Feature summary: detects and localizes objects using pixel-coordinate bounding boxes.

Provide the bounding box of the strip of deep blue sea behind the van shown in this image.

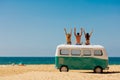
[0,57,120,65]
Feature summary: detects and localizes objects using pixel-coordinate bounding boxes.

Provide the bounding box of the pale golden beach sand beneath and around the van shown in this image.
[0,65,120,80]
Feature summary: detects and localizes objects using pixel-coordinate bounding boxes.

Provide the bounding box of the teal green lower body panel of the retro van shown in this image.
[55,56,108,70]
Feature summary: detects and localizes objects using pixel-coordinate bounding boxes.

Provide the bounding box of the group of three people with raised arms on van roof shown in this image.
[64,28,93,45]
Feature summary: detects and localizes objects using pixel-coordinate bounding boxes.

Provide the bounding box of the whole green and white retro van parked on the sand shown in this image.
[55,44,109,73]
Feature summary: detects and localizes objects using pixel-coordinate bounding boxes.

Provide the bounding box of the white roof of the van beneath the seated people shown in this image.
[57,44,104,48]
